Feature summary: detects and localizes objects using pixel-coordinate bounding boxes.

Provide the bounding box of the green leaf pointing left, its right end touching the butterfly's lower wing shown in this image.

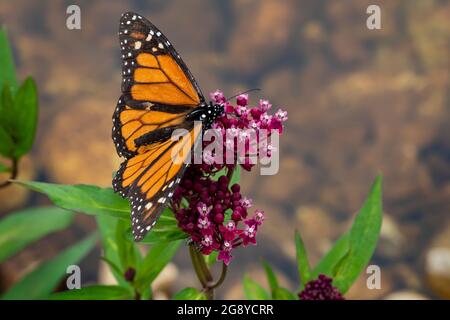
[15,181,130,220]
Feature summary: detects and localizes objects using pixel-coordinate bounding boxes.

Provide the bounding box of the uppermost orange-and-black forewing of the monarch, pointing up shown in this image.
[119,12,204,107]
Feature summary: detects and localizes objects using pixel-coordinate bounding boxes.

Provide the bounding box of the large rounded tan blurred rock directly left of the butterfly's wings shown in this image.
[39,98,120,186]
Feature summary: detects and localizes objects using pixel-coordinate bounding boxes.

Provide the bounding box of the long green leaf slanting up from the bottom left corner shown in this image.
[2,234,97,300]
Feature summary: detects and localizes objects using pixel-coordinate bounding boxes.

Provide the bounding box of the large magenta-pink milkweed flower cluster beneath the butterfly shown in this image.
[171,90,287,265]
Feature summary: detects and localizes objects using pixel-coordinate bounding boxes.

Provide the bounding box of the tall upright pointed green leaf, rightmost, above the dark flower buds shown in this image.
[333,176,383,293]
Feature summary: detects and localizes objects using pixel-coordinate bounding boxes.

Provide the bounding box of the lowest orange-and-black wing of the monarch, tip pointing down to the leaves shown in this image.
[113,124,199,241]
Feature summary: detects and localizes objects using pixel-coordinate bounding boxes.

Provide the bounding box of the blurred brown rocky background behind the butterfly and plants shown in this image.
[0,0,450,299]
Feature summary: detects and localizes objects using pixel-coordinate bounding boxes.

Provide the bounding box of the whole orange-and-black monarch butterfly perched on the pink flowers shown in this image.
[112,12,224,241]
